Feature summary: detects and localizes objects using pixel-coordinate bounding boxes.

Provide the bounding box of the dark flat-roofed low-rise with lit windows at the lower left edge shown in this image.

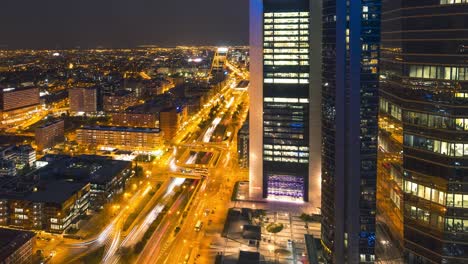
[0,177,91,233]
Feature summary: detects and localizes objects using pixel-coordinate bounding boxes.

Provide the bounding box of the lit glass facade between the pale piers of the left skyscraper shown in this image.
[263,0,310,201]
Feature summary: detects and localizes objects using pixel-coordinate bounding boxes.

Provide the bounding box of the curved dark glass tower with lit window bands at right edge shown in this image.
[379,0,468,263]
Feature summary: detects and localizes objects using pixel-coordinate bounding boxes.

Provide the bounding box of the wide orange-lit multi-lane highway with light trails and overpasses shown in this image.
[34,60,248,263]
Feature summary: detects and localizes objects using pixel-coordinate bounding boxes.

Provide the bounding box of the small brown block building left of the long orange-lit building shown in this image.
[35,119,65,151]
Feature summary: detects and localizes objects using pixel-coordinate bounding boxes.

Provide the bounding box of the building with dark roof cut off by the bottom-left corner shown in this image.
[0,228,36,264]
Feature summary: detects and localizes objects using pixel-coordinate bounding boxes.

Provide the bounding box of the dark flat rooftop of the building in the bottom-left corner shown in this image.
[0,228,36,261]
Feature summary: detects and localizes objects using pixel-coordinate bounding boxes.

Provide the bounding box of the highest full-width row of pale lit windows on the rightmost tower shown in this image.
[409,65,468,81]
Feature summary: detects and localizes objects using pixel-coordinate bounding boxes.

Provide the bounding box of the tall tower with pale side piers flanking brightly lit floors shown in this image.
[249,0,320,204]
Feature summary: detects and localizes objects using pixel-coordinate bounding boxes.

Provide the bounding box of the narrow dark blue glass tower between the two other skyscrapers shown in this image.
[321,0,380,264]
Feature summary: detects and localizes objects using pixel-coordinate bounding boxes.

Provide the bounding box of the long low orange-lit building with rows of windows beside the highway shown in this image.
[76,126,162,151]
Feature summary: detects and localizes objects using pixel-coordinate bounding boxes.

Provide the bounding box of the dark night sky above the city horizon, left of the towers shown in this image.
[0,0,248,49]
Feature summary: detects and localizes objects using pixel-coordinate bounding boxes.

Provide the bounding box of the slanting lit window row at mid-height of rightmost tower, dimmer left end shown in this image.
[404,134,468,157]
